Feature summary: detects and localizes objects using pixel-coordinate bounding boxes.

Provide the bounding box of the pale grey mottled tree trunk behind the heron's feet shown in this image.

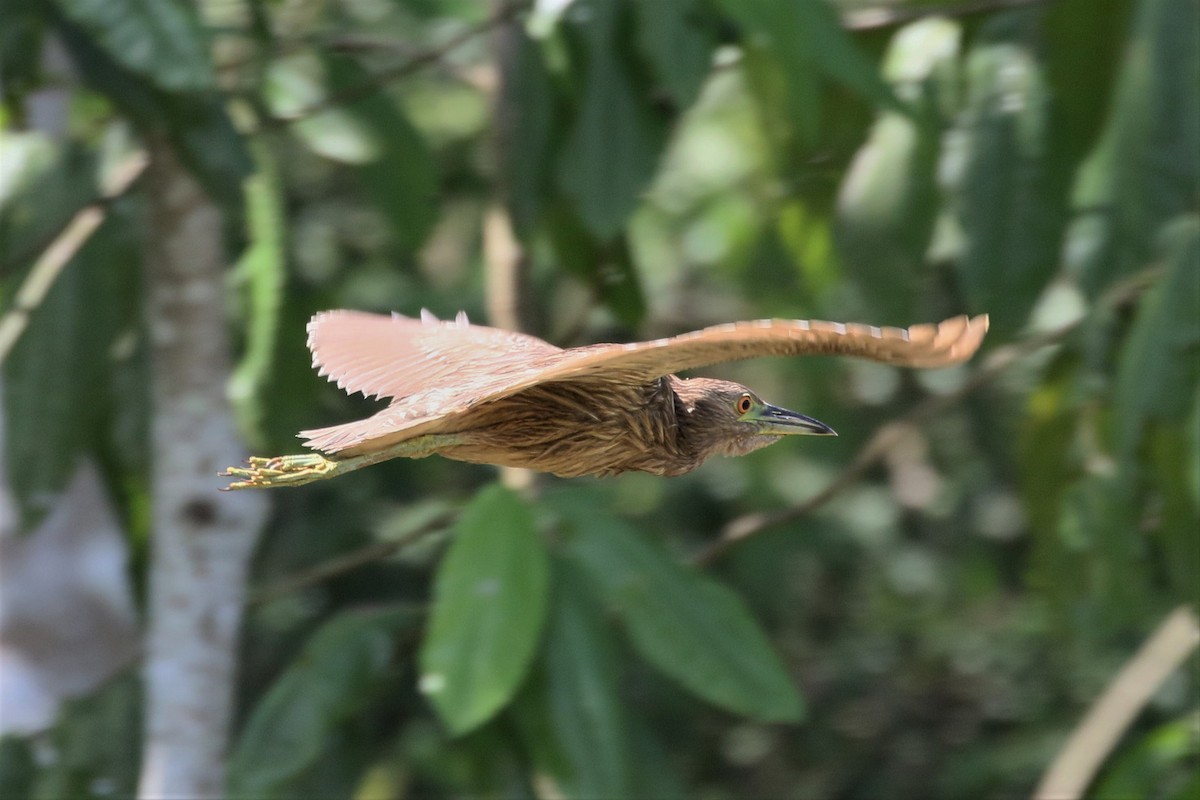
[138,142,266,799]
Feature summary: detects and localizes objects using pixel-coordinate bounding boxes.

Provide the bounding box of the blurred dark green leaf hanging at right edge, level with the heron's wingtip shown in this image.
[1112,215,1200,458]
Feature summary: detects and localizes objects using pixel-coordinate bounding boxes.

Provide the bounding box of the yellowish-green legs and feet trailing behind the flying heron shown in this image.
[217,434,460,492]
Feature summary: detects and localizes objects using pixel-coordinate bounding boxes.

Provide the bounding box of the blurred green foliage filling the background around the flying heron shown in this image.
[0,0,1200,799]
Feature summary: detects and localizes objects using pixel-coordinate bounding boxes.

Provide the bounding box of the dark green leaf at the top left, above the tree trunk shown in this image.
[58,0,216,91]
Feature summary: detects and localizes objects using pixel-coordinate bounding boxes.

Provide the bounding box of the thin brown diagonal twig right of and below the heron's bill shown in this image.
[692,267,1162,566]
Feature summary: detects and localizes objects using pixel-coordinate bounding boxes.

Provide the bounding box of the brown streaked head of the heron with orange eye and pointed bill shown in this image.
[676,378,838,457]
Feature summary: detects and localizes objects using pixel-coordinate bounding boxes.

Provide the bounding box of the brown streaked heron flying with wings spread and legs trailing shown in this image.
[221,311,988,489]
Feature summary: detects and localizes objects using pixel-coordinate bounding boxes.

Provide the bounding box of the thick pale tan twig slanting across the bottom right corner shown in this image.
[1033,606,1200,800]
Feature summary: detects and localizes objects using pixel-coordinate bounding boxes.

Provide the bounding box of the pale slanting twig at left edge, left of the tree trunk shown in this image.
[0,151,146,365]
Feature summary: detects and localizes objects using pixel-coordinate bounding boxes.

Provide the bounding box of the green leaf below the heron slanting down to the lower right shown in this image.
[558,503,804,722]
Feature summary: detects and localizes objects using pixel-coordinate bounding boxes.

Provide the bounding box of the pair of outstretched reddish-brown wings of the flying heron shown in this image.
[300,312,988,455]
